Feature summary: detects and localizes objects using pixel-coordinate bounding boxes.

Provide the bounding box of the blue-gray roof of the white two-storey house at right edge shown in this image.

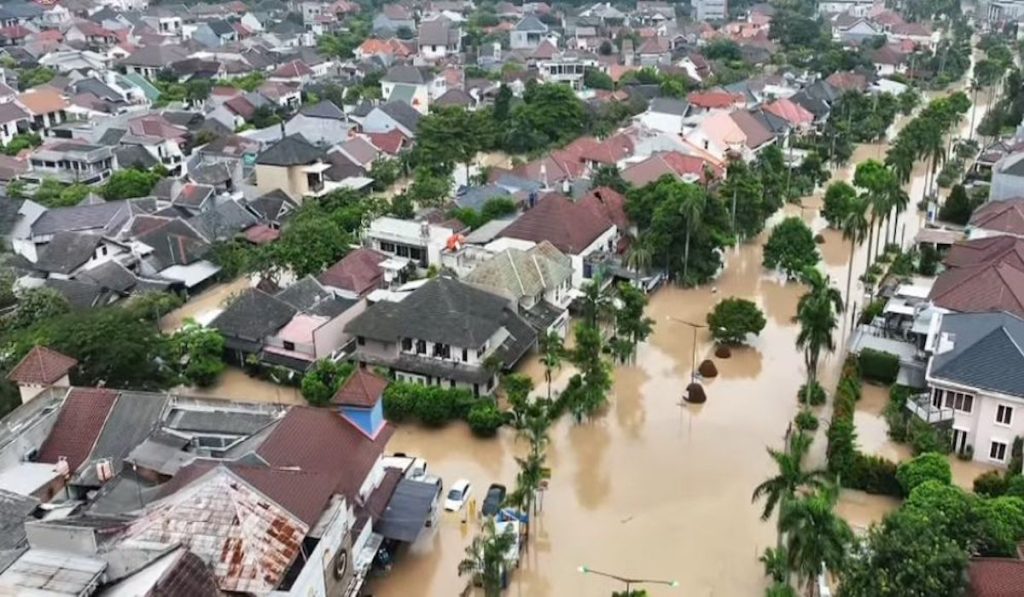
[930,312,1024,396]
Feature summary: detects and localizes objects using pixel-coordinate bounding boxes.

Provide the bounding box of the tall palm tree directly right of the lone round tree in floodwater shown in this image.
[797,267,843,392]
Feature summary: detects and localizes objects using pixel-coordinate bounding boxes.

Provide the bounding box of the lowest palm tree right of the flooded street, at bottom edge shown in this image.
[779,483,853,597]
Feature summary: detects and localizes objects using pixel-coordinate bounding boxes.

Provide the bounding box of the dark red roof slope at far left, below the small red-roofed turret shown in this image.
[39,388,118,471]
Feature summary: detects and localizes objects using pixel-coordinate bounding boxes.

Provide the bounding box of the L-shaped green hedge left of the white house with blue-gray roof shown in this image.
[825,357,902,496]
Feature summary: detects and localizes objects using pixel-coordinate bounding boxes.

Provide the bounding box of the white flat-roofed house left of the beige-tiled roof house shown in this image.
[362,216,455,270]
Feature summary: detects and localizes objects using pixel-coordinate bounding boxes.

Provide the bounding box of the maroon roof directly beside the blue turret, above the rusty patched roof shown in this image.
[257,407,394,499]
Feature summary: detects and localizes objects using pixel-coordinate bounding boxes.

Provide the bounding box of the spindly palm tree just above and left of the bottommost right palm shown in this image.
[751,432,828,565]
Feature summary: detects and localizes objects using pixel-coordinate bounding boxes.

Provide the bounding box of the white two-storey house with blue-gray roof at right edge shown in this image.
[921,311,1024,466]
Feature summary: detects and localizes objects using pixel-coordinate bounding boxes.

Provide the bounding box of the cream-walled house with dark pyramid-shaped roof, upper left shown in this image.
[255,135,331,203]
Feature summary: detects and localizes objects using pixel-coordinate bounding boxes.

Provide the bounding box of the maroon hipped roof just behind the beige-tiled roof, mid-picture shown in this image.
[501,194,614,255]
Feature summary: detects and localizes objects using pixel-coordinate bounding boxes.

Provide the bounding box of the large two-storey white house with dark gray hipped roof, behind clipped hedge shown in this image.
[346,276,537,395]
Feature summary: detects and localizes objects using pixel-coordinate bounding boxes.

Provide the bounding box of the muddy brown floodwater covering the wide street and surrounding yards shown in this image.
[368,77,995,597]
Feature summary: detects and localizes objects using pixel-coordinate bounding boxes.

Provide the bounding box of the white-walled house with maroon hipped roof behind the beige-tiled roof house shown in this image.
[500,187,629,288]
